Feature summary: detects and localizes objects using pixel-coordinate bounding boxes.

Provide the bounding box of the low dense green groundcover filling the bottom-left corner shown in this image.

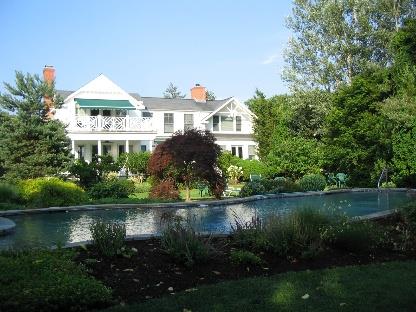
[0,250,112,312]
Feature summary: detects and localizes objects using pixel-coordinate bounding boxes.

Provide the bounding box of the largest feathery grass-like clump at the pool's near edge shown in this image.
[264,208,330,257]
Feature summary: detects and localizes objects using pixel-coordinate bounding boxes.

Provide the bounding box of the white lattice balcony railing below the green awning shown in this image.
[70,115,155,132]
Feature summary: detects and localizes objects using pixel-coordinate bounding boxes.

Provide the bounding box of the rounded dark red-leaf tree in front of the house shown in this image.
[148,129,225,201]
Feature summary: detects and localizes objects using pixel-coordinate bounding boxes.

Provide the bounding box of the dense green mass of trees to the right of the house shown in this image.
[247,5,416,187]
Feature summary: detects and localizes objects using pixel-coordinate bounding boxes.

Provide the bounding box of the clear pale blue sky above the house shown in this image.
[0,0,291,101]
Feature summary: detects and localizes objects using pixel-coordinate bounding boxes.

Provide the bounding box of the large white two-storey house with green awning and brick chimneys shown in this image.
[43,66,256,161]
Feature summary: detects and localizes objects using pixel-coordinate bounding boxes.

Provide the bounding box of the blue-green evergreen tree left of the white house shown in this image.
[0,72,71,180]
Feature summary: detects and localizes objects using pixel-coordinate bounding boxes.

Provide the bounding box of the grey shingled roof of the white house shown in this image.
[57,90,230,112]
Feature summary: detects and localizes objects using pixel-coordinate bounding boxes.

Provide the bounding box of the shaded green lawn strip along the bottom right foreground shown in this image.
[106,261,416,312]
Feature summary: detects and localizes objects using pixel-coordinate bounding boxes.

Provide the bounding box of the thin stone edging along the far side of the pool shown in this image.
[0,188,416,217]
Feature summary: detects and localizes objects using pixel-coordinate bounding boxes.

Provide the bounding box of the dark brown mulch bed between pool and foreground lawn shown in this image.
[77,214,416,303]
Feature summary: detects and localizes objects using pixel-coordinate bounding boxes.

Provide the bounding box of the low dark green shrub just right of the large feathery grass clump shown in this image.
[322,220,382,253]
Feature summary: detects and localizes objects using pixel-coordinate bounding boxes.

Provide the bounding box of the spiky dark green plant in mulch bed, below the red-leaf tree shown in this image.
[161,217,212,267]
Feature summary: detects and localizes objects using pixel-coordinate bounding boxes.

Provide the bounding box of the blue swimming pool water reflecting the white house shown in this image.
[0,191,416,249]
